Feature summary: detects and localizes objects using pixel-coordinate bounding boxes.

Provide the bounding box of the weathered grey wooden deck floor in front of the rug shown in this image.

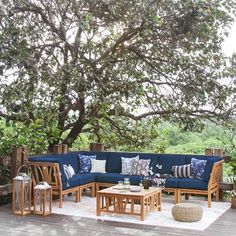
[0,206,236,236]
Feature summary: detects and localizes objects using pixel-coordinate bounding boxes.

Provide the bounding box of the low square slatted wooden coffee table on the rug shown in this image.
[97,185,161,220]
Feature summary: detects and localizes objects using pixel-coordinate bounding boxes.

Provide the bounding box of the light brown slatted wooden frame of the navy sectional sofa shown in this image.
[28,160,224,207]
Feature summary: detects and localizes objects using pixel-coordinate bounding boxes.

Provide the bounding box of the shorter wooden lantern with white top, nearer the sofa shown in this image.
[34,185,52,216]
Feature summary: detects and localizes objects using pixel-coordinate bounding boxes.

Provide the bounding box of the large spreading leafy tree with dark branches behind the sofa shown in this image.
[0,0,236,149]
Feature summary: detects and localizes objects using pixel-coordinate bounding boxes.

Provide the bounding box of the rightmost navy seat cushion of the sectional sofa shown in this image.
[178,178,208,190]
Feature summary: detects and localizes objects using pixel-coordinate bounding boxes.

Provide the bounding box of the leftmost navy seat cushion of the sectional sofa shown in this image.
[63,173,96,190]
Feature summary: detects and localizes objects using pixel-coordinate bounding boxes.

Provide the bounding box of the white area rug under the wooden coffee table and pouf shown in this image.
[52,196,230,230]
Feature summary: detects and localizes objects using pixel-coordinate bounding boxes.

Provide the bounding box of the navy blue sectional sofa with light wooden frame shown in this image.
[29,151,223,207]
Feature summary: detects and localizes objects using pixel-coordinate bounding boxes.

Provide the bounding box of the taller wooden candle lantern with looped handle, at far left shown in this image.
[12,165,32,216]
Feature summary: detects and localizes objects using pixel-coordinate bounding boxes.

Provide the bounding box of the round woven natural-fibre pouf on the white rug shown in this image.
[172,203,203,222]
